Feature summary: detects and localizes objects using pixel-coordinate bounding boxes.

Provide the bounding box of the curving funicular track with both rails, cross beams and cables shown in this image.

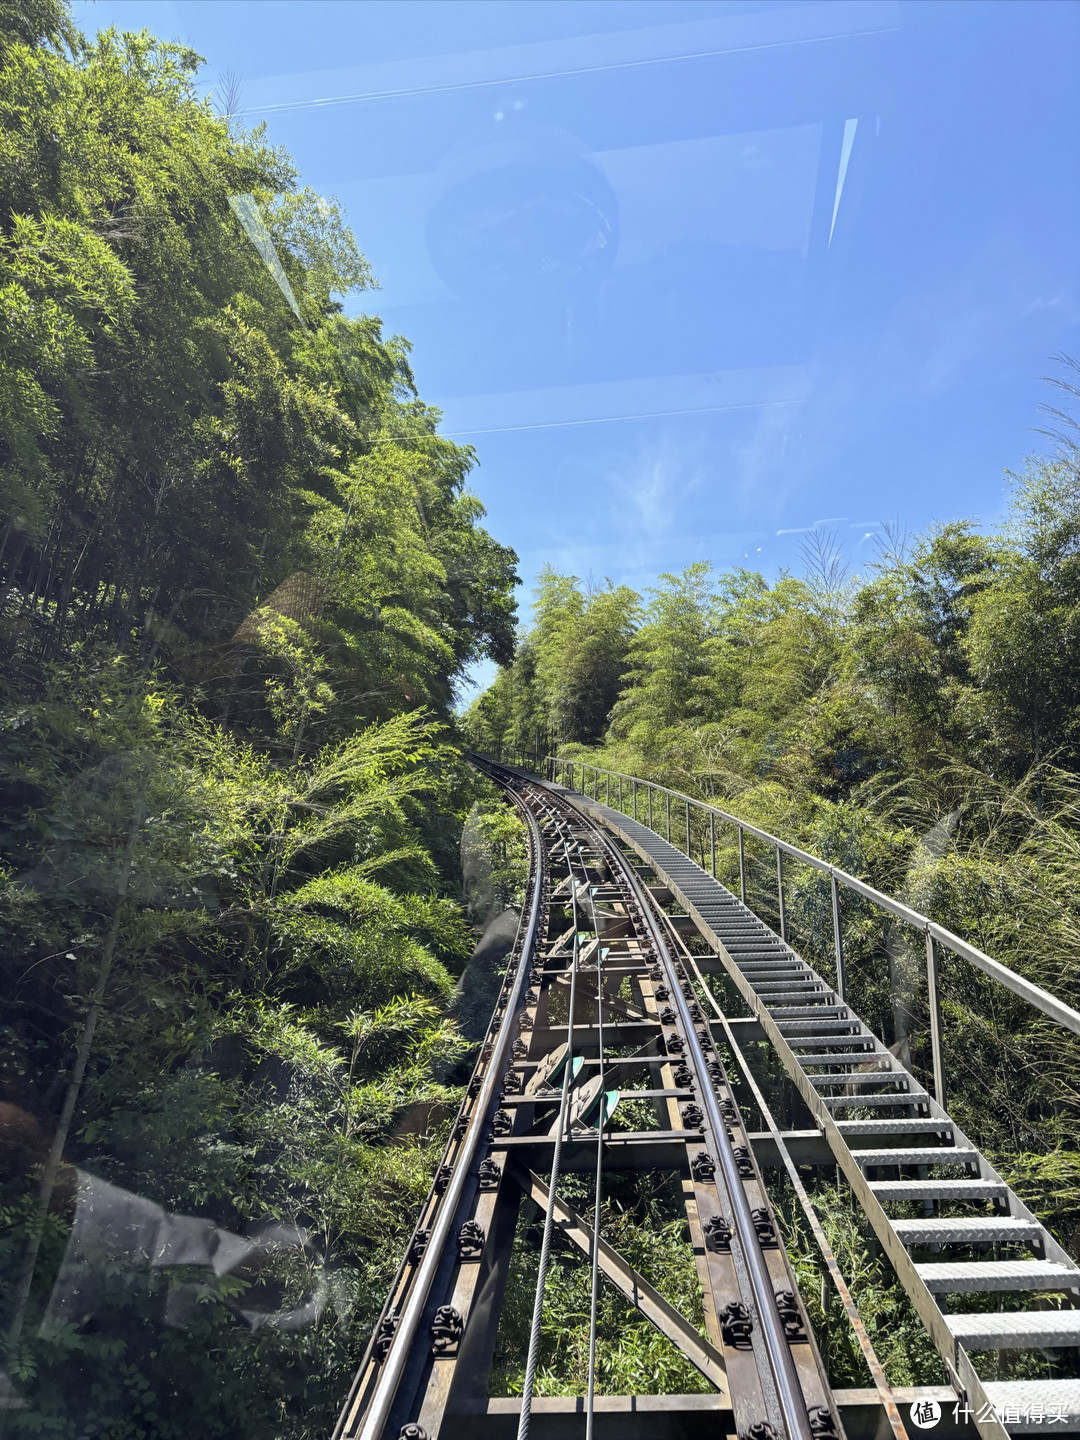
[336,762,840,1440]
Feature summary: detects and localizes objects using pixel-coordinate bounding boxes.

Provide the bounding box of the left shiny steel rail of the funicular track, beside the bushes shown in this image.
[348,789,544,1440]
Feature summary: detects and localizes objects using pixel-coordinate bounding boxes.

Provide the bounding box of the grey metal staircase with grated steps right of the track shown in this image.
[562,791,1080,1440]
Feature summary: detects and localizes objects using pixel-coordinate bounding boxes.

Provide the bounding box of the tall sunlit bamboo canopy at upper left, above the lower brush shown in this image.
[0,0,516,708]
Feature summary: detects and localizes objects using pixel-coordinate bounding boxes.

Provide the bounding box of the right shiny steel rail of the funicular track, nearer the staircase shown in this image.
[558,794,815,1440]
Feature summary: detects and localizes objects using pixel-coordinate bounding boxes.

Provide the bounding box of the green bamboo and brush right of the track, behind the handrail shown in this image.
[467,449,1080,1247]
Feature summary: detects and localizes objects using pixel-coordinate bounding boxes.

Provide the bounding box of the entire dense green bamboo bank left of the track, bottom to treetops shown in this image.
[0,0,516,1440]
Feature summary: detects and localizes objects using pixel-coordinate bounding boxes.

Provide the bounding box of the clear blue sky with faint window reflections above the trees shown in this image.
[75,0,1080,688]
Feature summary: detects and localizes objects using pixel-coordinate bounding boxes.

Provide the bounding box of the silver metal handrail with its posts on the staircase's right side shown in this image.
[500,747,1080,1104]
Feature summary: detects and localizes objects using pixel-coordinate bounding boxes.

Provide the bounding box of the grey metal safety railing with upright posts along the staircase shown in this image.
[495,747,1080,1106]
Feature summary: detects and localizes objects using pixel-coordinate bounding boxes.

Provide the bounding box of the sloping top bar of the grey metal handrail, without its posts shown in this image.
[521,756,1080,1035]
